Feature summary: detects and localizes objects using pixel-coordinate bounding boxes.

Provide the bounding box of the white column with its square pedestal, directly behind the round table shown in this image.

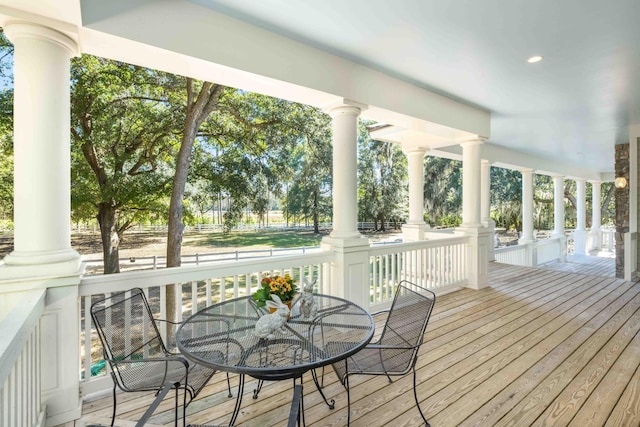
[321,100,370,307]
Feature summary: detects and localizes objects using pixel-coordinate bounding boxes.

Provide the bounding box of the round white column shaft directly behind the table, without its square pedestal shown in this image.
[329,105,361,239]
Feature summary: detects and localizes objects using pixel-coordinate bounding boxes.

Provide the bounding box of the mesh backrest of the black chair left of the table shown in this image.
[91,288,167,370]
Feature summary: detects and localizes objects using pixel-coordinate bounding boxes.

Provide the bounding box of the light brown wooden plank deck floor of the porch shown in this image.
[81,263,640,427]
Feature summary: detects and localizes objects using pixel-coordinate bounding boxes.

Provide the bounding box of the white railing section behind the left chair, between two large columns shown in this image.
[79,252,332,394]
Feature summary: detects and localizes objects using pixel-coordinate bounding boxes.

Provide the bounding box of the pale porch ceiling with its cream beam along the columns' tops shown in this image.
[0,0,640,179]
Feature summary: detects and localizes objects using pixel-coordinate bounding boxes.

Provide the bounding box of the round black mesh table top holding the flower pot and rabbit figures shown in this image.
[177,294,374,380]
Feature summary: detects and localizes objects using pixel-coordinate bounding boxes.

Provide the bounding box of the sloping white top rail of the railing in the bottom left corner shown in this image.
[0,289,47,384]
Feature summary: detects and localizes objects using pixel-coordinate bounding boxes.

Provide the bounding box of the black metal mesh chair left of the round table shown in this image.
[91,288,231,426]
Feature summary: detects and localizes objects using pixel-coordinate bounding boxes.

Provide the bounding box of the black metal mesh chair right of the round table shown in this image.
[329,280,436,427]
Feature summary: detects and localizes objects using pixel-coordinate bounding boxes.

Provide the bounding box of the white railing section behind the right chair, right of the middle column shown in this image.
[369,236,469,306]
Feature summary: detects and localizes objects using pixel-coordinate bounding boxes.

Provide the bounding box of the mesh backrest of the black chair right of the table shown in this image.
[378,280,436,370]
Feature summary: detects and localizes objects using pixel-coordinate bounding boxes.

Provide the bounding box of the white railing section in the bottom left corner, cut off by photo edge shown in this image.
[0,290,46,427]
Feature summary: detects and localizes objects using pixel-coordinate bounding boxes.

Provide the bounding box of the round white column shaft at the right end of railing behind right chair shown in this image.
[460,139,483,228]
